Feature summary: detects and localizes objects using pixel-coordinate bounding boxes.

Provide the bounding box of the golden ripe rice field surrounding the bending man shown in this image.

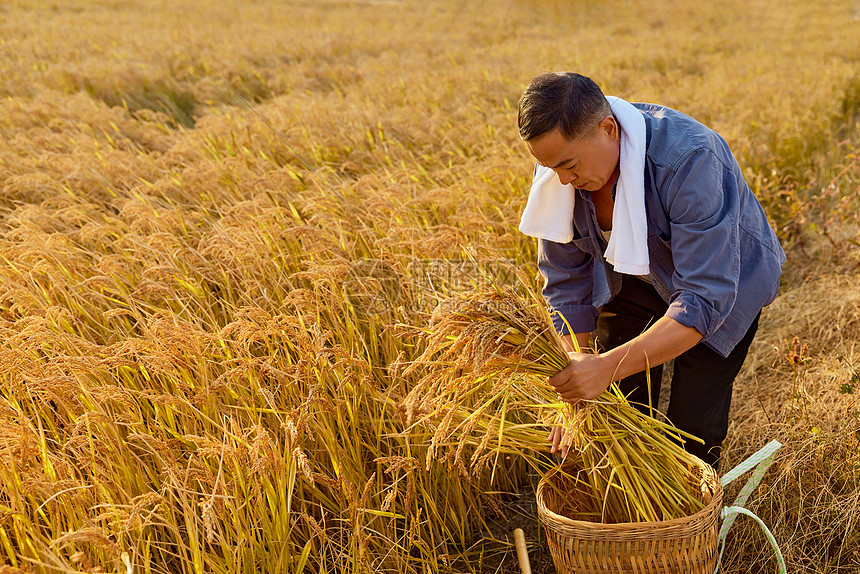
[0,0,860,574]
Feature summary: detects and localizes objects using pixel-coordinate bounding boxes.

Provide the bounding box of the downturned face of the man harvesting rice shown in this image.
[526,117,619,191]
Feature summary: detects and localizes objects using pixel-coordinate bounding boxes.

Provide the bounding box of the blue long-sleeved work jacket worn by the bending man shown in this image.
[538,104,785,357]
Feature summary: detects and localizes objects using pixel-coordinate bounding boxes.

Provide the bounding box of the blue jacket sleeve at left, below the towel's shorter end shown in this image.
[538,239,597,335]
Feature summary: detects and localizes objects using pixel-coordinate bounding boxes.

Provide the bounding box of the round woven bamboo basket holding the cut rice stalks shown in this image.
[537,462,723,574]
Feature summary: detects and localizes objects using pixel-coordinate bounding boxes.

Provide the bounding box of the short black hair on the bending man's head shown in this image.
[517,72,612,141]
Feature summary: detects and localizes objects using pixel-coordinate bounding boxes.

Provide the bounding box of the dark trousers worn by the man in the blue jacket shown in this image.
[596,275,758,468]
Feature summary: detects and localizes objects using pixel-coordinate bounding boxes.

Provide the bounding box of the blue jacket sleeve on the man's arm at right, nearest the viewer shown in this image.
[666,149,740,338]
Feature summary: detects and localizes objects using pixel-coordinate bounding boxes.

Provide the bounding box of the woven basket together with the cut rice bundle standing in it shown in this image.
[420,286,721,572]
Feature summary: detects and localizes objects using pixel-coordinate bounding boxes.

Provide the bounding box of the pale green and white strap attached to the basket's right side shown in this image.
[714,440,787,574]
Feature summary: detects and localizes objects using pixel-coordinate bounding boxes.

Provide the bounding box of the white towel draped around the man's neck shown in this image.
[519,96,649,275]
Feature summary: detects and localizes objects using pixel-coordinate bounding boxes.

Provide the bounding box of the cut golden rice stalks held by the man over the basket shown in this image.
[419,286,703,523]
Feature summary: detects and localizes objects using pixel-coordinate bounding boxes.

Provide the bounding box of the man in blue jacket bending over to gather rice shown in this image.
[519,72,785,466]
